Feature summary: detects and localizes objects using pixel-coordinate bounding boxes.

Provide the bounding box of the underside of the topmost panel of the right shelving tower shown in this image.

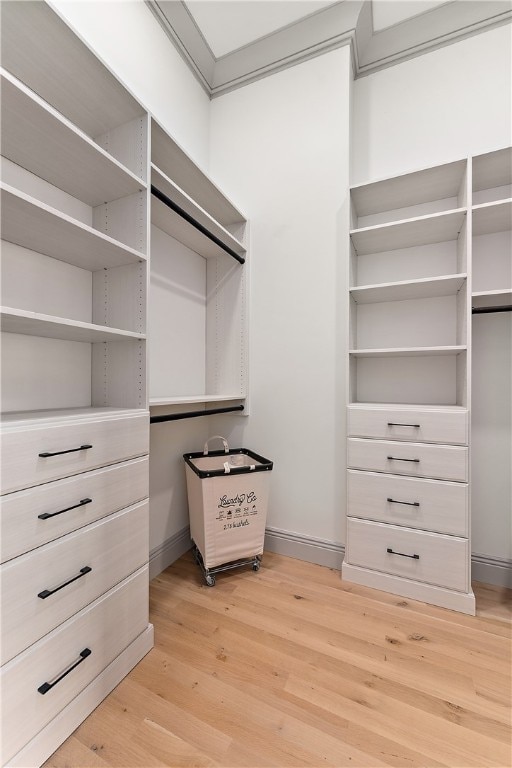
[351,160,466,216]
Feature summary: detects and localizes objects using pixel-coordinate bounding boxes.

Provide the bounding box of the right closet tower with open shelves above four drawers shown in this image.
[343,161,474,613]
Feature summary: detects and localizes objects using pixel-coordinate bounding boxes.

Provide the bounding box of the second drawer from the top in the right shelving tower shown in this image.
[348,437,468,482]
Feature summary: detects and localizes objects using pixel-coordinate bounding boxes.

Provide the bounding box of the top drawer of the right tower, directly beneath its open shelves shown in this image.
[348,407,468,445]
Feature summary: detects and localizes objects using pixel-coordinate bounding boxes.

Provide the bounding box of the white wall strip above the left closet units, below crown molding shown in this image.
[52,0,210,169]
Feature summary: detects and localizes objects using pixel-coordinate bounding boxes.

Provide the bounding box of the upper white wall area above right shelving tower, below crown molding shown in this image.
[351,25,512,184]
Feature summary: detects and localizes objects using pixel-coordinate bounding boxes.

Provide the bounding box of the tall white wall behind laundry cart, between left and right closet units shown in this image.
[210,48,350,542]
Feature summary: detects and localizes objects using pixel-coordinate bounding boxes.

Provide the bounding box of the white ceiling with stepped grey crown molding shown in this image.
[146,0,512,98]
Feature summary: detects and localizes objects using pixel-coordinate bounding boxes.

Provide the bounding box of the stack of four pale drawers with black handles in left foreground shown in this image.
[0,411,151,765]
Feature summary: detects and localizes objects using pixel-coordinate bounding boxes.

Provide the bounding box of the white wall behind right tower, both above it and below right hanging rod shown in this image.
[351,25,512,560]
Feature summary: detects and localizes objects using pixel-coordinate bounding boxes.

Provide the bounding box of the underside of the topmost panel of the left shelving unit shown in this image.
[2,2,144,138]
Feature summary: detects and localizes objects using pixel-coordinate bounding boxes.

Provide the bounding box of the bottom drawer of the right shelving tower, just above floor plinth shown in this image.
[347,519,469,592]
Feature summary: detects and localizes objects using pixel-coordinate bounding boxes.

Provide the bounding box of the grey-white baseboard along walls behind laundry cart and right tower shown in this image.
[149,527,512,589]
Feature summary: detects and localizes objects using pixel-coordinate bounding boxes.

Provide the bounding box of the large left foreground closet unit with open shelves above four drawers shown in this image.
[0,2,153,766]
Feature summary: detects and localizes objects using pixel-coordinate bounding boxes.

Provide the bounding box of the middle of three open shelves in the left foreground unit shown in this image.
[0,184,146,271]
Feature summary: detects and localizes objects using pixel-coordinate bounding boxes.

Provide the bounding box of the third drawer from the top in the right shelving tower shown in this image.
[347,470,468,536]
